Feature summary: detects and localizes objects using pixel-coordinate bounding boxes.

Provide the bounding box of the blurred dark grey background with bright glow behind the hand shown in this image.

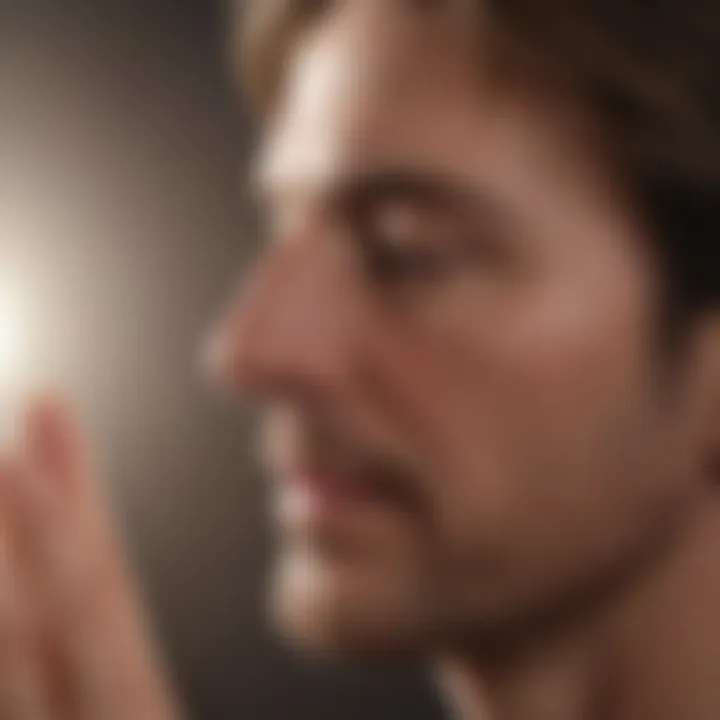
[0,0,440,720]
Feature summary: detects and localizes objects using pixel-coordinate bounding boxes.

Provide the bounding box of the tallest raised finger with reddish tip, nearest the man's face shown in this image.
[16,396,179,720]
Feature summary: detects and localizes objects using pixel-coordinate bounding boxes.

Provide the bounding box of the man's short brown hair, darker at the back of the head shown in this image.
[238,0,720,334]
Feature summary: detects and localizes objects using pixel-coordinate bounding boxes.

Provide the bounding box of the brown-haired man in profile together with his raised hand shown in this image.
[0,0,720,720]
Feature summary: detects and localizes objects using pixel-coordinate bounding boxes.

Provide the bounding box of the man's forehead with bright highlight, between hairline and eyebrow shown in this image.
[258,0,600,205]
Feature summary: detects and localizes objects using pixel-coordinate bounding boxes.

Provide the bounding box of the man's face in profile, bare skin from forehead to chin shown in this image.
[207,0,688,652]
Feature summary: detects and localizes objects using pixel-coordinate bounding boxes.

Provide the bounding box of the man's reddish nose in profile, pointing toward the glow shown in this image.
[205,236,358,400]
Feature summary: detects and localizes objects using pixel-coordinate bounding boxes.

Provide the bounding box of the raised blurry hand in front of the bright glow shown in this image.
[0,398,178,720]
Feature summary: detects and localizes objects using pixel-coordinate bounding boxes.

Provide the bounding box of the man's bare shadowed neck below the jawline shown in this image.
[439,503,720,720]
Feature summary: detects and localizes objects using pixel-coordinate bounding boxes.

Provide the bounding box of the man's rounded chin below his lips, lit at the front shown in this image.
[268,552,431,661]
